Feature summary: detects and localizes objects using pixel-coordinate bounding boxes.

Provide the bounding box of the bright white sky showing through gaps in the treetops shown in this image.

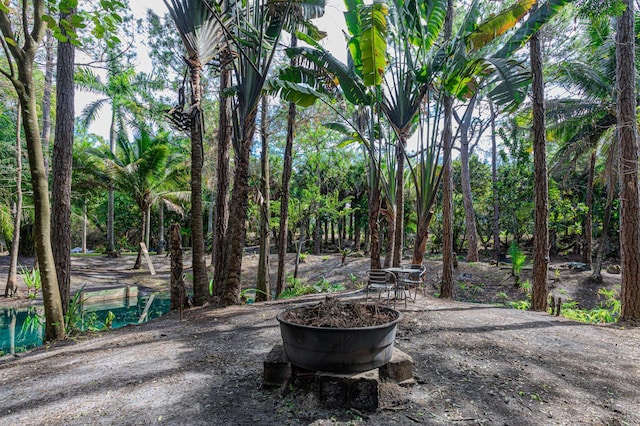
[81,0,346,139]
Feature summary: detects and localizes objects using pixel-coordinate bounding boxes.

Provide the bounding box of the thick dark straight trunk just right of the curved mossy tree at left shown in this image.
[51,10,75,312]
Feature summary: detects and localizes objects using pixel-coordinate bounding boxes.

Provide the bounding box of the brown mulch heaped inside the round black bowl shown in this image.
[281,298,399,328]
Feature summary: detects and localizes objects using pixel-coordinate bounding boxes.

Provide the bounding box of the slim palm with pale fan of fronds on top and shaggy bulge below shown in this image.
[163,0,226,305]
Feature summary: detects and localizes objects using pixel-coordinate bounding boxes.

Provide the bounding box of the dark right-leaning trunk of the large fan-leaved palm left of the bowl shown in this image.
[222,108,257,306]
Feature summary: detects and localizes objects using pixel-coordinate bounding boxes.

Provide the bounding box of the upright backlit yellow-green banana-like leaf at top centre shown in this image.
[360,3,389,86]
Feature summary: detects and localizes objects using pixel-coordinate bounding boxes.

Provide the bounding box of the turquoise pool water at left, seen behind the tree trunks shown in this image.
[0,294,171,356]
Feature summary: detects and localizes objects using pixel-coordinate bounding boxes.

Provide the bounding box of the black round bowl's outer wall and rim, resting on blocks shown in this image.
[276,307,403,374]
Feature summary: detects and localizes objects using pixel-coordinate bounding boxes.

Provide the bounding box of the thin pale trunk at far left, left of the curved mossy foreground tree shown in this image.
[4,103,22,297]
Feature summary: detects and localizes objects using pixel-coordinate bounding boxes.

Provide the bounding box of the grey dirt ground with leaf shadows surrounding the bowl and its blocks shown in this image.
[0,296,640,425]
